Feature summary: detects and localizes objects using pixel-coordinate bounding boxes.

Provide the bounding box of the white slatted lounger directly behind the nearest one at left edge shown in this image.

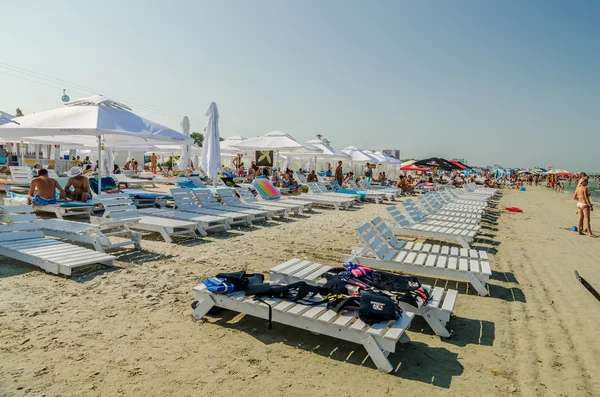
[38,219,142,252]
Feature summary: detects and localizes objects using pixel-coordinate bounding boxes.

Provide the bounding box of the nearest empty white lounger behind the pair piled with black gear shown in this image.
[342,218,492,296]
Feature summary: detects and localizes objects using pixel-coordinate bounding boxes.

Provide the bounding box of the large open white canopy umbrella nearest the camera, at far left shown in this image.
[0,95,192,147]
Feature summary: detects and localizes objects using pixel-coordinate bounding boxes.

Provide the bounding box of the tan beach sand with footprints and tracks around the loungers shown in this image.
[0,187,600,397]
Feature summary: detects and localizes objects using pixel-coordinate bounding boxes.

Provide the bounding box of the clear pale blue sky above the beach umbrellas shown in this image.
[0,0,600,171]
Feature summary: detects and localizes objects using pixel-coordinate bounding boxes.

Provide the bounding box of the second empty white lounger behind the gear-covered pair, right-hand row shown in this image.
[386,207,479,249]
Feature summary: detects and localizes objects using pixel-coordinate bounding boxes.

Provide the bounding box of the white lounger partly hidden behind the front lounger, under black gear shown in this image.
[269,258,458,338]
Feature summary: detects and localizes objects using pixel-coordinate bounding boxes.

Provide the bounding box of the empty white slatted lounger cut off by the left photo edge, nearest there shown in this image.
[0,206,115,276]
